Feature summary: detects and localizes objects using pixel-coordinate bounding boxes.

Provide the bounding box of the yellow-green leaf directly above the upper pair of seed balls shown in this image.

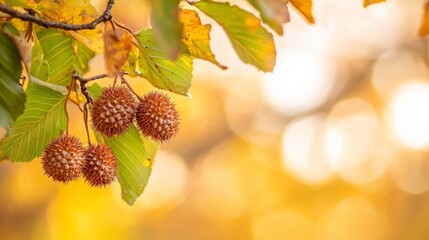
[124,29,193,95]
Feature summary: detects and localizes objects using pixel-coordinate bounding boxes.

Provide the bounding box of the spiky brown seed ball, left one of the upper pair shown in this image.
[91,87,136,137]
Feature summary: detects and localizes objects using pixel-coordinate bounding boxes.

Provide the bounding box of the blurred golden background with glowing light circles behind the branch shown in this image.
[0,0,429,240]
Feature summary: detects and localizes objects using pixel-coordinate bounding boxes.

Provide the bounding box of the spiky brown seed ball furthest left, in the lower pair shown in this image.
[42,135,85,182]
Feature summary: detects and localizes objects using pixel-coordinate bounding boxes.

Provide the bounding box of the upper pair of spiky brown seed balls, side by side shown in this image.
[92,87,179,142]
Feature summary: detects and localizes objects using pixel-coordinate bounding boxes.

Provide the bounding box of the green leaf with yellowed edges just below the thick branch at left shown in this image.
[31,29,94,86]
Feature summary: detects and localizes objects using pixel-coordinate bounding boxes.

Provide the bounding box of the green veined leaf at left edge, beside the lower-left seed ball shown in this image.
[0,83,66,162]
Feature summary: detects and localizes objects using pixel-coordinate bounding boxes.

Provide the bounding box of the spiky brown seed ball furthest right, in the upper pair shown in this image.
[136,92,179,142]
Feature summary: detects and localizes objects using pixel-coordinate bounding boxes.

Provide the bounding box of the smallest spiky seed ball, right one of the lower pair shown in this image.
[82,144,117,187]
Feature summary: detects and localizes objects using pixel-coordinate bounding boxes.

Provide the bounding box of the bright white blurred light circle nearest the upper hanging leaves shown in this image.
[263,50,335,115]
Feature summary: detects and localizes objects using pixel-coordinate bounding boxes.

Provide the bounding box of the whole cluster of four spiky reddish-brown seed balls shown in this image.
[42,86,179,187]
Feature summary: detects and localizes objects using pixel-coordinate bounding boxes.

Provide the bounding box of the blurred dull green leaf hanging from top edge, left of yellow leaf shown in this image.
[150,0,182,60]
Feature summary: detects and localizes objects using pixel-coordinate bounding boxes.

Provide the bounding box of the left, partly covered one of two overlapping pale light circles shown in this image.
[283,115,332,184]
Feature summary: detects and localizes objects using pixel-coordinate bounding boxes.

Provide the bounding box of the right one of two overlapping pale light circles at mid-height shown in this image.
[325,98,386,185]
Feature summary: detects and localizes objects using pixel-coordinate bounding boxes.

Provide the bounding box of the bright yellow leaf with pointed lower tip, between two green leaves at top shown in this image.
[179,9,227,69]
